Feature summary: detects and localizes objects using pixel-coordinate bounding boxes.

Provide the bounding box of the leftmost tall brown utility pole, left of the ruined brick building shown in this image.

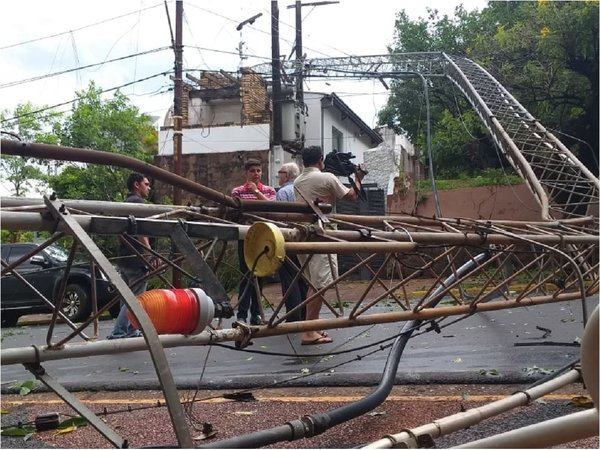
[173,0,183,205]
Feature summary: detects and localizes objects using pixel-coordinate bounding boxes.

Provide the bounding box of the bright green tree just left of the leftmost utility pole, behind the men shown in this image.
[49,82,158,201]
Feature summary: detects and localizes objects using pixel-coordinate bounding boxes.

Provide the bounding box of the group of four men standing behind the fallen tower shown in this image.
[109,146,362,345]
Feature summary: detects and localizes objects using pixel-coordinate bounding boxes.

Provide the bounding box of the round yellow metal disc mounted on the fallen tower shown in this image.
[244,222,285,277]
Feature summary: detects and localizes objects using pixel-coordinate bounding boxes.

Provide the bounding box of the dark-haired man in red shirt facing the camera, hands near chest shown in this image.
[231,159,276,325]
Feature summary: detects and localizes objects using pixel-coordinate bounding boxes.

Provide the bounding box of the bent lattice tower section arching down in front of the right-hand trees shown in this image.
[254,52,600,220]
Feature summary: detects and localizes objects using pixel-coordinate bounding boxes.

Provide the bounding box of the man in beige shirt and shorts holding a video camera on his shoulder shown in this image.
[294,146,365,345]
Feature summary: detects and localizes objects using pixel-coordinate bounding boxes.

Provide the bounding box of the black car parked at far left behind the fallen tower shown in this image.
[0,243,119,326]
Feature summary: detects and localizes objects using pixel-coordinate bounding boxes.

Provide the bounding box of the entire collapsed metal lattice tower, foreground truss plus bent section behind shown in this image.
[2,53,599,447]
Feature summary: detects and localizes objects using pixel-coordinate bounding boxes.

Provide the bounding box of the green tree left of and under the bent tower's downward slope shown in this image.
[379,6,500,177]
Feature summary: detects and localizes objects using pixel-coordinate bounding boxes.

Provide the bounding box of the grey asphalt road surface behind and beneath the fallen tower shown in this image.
[1,297,598,393]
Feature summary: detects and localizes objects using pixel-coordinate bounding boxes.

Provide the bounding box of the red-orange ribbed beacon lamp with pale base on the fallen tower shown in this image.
[127,288,215,334]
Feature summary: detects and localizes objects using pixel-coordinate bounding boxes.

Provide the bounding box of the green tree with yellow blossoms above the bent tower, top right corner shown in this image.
[473,1,600,174]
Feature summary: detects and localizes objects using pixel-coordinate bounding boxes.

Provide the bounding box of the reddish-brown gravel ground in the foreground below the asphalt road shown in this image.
[1,385,599,448]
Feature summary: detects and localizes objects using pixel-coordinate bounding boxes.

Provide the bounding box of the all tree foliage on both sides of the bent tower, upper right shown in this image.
[379,1,599,175]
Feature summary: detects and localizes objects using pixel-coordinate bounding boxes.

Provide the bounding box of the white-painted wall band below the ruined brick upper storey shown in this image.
[158,124,269,155]
